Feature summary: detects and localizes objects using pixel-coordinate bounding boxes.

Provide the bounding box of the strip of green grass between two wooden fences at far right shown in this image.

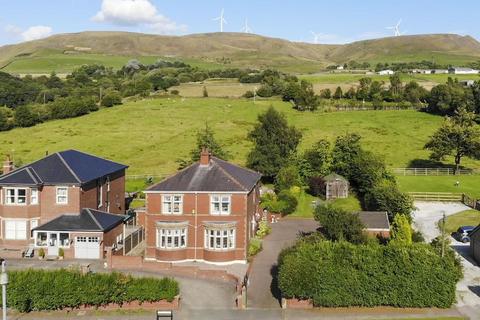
[396,175,480,199]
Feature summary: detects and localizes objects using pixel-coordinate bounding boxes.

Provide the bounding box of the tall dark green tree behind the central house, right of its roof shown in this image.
[247,107,302,180]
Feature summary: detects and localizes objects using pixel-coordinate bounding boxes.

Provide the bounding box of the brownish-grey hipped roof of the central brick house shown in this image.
[147,157,261,192]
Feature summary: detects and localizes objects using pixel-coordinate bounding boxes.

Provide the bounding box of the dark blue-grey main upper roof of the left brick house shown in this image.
[0,150,128,185]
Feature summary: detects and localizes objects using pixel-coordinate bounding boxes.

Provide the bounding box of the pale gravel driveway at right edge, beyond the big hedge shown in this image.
[414,202,480,319]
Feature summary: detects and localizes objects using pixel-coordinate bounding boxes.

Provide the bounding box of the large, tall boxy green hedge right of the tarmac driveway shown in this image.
[278,241,462,308]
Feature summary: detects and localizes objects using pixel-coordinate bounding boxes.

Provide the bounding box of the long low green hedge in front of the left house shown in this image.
[3,269,179,312]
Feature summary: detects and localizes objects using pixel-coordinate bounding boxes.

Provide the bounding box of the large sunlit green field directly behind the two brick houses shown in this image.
[0,98,480,176]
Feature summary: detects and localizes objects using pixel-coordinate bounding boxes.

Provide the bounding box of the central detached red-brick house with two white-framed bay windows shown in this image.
[138,151,261,263]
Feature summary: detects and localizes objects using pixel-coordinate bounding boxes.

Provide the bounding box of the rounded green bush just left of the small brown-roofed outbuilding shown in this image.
[314,205,366,244]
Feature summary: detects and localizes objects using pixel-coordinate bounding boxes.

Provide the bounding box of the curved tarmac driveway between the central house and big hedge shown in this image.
[247,219,318,308]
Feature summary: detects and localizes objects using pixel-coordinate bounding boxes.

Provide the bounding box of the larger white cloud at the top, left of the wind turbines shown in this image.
[92,0,187,34]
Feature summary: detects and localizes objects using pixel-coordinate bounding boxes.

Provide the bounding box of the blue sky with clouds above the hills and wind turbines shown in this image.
[0,0,480,45]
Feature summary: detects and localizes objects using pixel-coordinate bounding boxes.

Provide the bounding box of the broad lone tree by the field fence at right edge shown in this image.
[425,108,480,172]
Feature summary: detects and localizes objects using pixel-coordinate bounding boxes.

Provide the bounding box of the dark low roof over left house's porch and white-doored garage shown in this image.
[33,209,127,232]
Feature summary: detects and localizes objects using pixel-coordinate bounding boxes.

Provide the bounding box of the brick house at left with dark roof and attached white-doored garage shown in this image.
[0,150,127,258]
